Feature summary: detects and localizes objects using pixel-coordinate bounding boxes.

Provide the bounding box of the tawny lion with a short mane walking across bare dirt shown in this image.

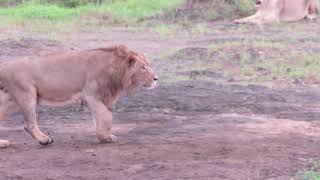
[0,46,158,148]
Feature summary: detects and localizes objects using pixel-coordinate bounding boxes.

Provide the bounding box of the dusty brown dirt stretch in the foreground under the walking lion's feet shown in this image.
[0,82,320,180]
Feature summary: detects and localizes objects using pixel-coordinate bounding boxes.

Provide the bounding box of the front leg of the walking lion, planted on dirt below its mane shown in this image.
[85,97,117,143]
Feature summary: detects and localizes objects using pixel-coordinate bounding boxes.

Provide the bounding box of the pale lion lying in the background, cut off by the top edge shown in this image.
[234,0,319,24]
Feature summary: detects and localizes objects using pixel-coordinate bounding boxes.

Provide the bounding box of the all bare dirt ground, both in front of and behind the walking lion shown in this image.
[0,22,320,180]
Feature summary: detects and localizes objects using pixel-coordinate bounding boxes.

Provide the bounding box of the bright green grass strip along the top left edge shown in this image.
[0,0,182,20]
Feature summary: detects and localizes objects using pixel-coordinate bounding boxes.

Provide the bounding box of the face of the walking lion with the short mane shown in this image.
[128,54,158,90]
